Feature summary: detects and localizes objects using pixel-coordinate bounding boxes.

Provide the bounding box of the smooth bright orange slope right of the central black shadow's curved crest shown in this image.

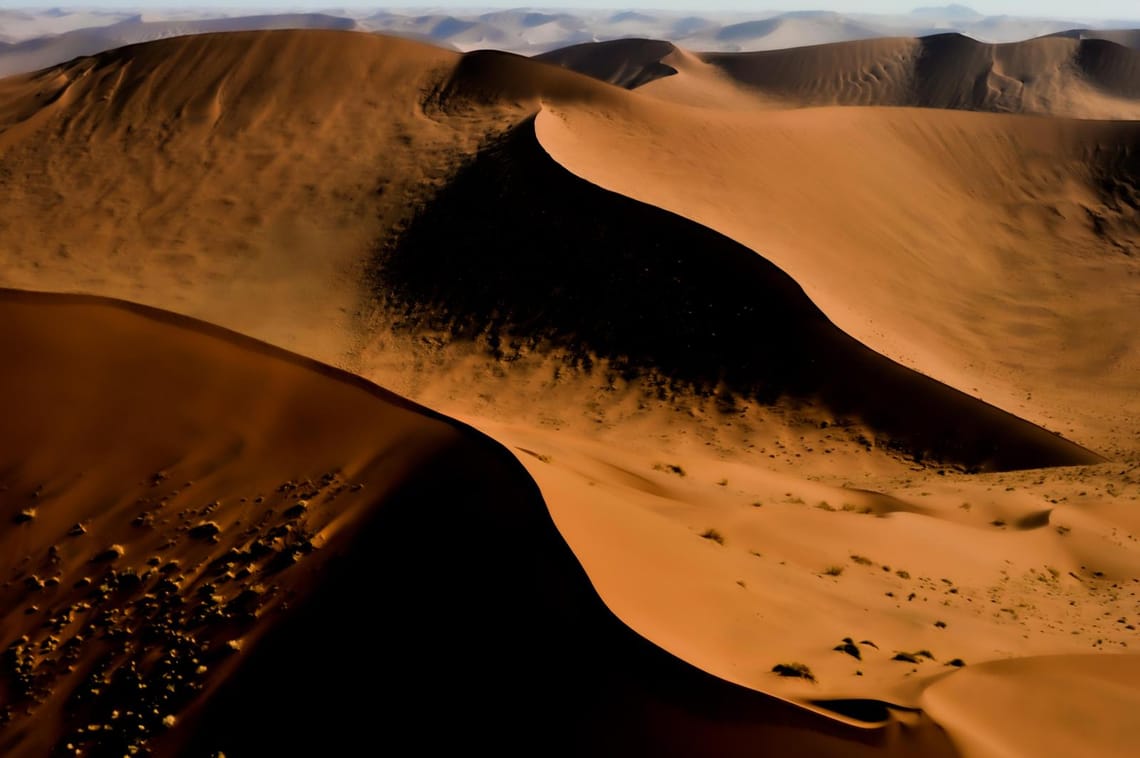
[537,98,1140,455]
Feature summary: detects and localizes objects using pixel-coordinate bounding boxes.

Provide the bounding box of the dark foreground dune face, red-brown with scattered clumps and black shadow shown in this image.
[0,291,953,756]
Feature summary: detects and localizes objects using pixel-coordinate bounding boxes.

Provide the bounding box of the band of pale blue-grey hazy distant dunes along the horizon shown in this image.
[0,6,1140,75]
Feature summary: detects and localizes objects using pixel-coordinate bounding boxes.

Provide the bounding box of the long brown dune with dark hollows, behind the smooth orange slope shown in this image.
[702,34,1140,119]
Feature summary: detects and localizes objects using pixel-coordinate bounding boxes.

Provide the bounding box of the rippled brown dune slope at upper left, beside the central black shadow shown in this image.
[0,31,495,361]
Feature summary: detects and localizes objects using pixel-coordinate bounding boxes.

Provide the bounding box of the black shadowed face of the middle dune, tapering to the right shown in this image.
[374,106,1099,468]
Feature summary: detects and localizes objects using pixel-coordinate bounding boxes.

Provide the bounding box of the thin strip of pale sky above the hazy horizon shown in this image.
[5,0,1140,19]
